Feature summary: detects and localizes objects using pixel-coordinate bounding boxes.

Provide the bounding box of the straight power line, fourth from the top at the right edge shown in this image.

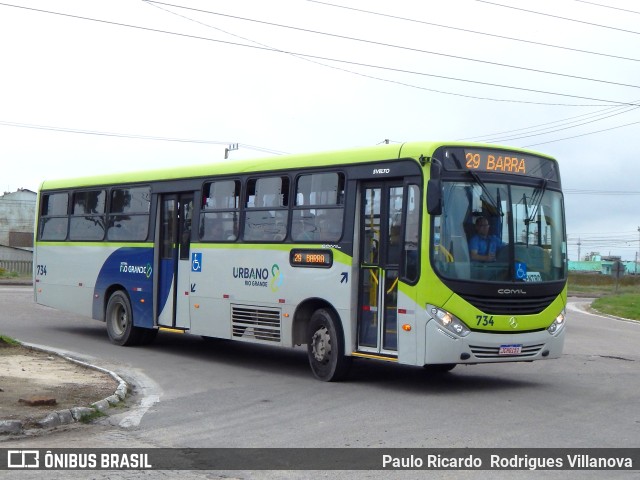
[144,0,640,88]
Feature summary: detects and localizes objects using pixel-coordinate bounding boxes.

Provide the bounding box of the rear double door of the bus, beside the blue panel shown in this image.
[154,193,193,329]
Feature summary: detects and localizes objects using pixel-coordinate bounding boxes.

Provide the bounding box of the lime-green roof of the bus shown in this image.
[40,142,551,190]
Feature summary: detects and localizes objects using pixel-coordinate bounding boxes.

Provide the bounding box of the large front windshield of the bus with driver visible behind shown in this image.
[431,181,566,283]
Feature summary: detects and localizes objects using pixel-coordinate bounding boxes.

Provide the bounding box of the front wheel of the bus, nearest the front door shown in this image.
[307,309,351,382]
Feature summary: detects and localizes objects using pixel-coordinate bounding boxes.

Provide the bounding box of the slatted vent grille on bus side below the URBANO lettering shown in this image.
[231,305,280,342]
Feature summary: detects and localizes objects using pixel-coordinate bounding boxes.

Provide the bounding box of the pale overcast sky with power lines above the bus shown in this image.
[0,0,640,260]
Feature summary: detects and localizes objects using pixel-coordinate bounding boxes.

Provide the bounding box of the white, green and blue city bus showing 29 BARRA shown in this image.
[34,142,567,381]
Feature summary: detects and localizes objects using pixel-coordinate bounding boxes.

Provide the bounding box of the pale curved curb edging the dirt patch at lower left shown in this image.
[0,343,129,435]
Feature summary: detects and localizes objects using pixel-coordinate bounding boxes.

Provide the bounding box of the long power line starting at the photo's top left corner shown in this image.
[0,3,635,106]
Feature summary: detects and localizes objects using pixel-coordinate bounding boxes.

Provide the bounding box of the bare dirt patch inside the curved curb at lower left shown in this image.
[0,339,118,427]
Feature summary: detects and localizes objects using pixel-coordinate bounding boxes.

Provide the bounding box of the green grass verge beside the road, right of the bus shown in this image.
[569,273,640,320]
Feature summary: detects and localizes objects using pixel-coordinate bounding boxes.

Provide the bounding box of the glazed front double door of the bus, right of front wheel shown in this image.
[358,181,404,356]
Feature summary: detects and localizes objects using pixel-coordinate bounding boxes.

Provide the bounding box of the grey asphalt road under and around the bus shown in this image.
[0,286,640,478]
